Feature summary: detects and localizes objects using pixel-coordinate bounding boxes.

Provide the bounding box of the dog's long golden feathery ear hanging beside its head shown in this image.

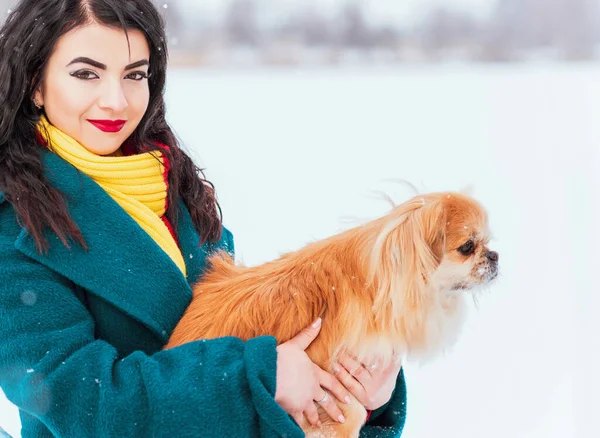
[370,195,446,325]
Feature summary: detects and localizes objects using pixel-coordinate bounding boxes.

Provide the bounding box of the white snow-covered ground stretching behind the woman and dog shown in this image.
[0,64,600,438]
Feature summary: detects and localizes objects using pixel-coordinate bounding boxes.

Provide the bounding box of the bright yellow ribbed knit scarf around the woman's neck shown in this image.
[38,116,186,276]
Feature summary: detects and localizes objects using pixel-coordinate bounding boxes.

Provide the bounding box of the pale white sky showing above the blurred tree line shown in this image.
[176,0,497,24]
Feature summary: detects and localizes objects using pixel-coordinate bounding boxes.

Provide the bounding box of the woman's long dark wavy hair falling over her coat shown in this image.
[0,0,222,252]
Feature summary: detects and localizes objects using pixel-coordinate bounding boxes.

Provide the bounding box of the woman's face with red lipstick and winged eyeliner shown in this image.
[35,24,150,155]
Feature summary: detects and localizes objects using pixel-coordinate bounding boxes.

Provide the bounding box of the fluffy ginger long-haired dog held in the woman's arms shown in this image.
[166,193,498,437]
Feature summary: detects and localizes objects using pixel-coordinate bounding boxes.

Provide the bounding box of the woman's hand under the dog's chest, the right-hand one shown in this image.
[333,352,402,411]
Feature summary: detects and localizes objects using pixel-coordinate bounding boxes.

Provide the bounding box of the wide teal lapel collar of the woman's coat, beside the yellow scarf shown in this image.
[10,151,211,343]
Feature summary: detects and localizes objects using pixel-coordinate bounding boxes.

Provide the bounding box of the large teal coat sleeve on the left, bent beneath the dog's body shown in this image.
[0,206,303,437]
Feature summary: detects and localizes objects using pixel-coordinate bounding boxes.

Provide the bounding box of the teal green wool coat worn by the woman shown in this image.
[0,152,406,438]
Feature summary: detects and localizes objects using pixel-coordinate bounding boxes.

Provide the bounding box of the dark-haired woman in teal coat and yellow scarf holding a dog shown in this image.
[0,0,405,437]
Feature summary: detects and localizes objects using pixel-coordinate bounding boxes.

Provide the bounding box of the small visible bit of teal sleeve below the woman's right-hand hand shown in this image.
[360,370,406,438]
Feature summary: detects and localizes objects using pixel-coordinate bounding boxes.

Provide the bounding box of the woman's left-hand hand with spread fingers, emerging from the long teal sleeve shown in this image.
[275,318,350,427]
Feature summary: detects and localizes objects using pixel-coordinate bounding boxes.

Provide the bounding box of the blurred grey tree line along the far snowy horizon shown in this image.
[0,0,600,62]
